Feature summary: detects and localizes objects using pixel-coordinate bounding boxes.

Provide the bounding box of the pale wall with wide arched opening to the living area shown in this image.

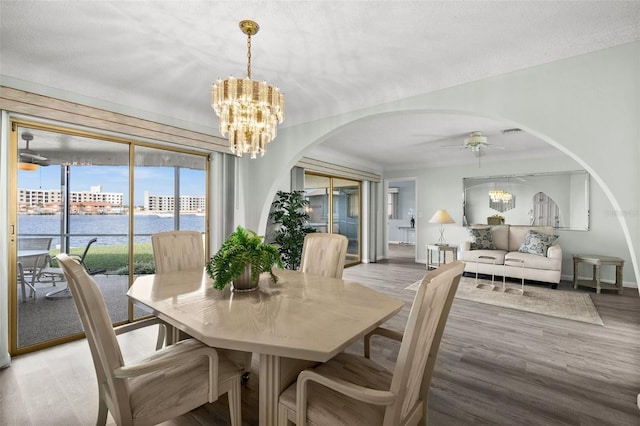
[243,42,640,288]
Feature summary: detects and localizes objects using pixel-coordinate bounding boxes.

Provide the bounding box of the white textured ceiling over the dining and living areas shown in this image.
[0,0,640,169]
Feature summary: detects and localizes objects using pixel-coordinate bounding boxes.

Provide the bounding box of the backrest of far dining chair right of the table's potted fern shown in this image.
[300,232,349,278]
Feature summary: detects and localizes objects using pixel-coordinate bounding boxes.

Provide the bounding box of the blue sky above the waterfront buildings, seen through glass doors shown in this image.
[18,165,206,206]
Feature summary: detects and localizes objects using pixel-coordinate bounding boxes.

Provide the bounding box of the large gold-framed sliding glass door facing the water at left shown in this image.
[9,120,208,355]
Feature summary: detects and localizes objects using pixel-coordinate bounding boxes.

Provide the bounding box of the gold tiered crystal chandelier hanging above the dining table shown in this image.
[211,20,284,158]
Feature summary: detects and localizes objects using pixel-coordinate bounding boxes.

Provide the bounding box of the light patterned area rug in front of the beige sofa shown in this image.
[407,277,604,325]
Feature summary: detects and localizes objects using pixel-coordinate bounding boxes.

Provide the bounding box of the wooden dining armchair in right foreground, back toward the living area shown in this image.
[278,261,464,426]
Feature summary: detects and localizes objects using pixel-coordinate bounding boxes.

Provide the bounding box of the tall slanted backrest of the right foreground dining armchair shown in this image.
[384,261,464,425]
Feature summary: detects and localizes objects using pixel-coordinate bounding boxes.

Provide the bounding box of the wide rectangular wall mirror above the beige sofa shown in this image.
[462,170,589,231]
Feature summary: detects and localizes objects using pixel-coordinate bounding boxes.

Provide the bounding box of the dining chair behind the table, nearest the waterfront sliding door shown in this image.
[151,231,252,374]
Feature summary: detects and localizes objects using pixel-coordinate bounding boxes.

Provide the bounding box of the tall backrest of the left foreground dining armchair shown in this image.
[56,253,131,424]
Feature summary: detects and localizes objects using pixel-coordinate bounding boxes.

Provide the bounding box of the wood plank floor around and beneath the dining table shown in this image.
[0,251,640,426]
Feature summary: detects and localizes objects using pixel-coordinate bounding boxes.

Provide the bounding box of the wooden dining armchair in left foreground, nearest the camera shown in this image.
[56,253,241,426]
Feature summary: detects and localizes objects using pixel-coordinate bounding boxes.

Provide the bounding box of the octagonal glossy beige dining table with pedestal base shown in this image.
[127,269,404,426]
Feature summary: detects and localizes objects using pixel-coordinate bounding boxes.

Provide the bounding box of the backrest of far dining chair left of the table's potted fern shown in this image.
[151,231,204,273]
